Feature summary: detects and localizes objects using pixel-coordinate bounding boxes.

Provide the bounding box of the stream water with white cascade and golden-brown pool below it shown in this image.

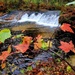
[0,11,60,37]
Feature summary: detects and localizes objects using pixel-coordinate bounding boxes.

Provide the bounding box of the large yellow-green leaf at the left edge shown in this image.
[0,29,11,43]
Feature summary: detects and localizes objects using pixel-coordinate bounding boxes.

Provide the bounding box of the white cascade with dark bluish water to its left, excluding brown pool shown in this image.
[0,11,60,27]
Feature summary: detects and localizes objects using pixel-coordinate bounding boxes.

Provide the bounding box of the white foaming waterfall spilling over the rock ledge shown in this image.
[18,11,60,27]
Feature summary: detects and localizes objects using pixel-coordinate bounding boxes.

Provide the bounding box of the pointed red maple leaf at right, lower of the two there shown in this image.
[59,41,74,53]
